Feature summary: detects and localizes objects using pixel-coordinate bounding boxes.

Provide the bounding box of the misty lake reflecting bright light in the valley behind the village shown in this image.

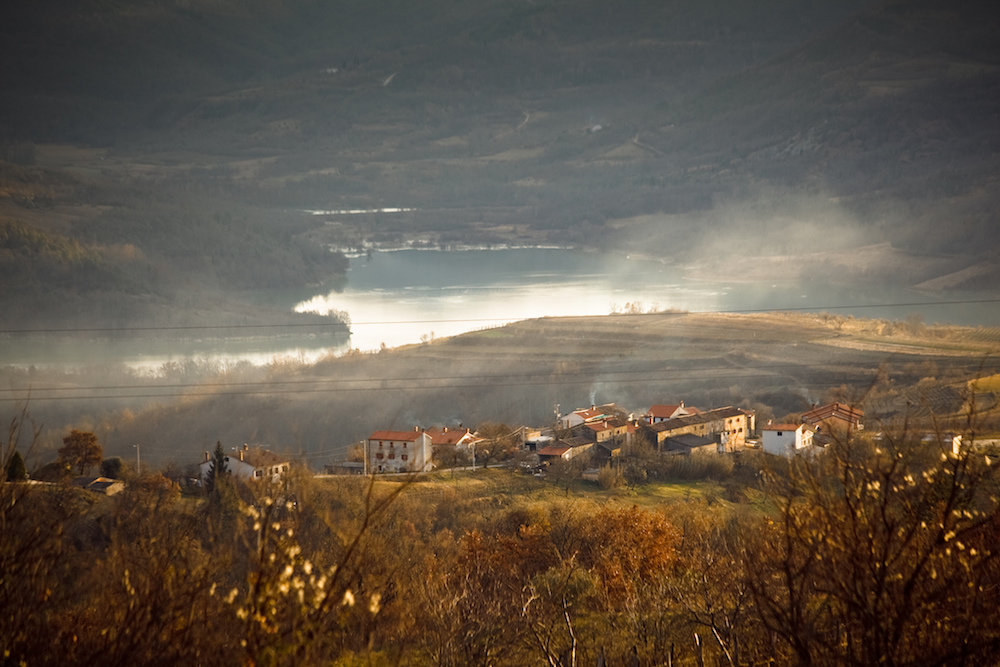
[0,248,1000,370]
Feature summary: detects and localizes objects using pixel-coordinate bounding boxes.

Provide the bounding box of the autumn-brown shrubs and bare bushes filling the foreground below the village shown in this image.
[0,414,1000,667]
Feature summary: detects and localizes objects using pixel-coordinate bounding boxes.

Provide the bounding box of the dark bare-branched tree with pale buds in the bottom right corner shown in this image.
[746,414,1000,665]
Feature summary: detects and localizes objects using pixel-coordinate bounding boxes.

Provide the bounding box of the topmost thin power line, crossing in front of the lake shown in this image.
[0,298,1000,335]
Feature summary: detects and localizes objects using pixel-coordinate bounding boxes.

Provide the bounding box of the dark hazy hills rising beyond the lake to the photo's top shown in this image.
[0,0,1000,332]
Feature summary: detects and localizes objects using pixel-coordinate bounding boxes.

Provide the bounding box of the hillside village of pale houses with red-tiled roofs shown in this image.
[191,401,864,488]
